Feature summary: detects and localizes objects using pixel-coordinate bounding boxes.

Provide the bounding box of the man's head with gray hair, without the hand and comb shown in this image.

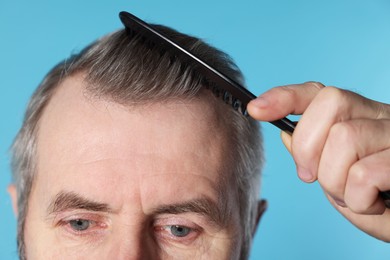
[10,23,265,259]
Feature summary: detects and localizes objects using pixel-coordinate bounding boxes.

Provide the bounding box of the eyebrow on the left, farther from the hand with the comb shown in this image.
[47,191,112,215]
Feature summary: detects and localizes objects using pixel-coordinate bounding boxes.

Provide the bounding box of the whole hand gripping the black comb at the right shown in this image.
[248,82,390,242]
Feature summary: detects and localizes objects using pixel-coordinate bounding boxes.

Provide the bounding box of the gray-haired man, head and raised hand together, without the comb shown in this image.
[9,14,390,259]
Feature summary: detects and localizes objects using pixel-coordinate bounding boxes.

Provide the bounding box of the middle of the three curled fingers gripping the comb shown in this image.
[318,119,390,205]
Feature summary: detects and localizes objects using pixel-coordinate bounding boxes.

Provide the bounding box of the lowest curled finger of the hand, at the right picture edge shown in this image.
[344,148,390,214]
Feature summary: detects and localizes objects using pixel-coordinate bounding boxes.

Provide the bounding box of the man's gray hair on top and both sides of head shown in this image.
[12,25,263,259]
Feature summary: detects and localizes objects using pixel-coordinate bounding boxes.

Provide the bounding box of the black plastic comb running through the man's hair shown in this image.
[119,12,295,133]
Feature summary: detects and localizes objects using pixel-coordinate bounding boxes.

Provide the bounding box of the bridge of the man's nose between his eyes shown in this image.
[116,221,159,260]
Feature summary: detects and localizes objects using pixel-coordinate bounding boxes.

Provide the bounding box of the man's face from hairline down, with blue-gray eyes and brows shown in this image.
[21,76,242,259]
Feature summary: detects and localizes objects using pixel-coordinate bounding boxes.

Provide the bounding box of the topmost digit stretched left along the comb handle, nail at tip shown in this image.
[247,82,324,121]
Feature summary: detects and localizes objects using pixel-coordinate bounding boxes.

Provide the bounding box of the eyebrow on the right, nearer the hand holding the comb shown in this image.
[152,198,226,227]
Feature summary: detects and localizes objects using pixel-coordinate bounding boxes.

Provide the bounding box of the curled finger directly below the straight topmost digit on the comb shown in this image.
[292,87,390,182]
